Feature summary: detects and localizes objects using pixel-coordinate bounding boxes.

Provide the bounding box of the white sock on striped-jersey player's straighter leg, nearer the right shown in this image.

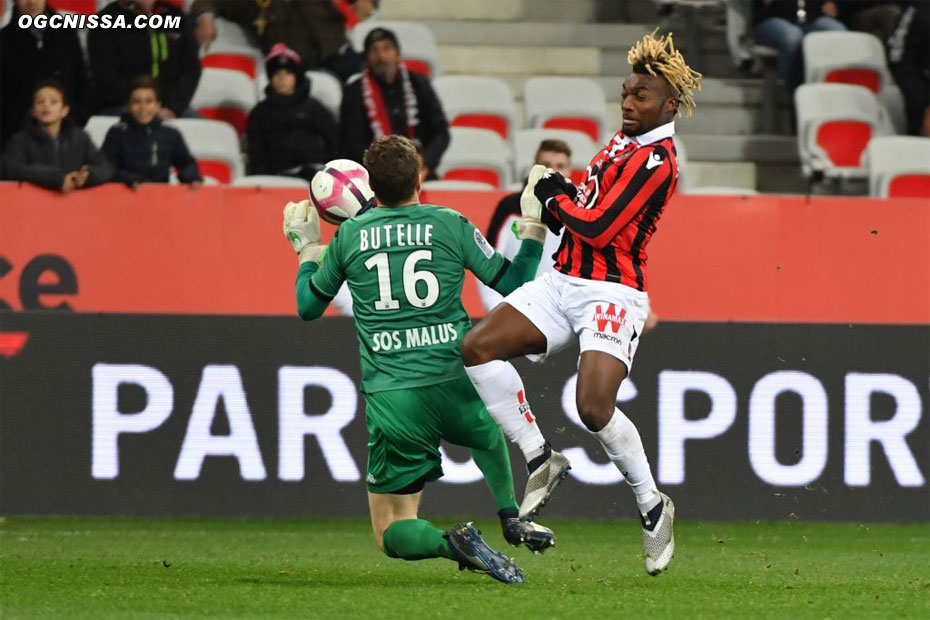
[594,408,661,514]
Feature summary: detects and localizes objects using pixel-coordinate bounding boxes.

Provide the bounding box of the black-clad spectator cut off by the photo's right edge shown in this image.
[888,0,930,137]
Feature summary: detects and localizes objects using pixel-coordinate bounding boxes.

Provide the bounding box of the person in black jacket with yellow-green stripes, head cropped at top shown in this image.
[88,0,200,120]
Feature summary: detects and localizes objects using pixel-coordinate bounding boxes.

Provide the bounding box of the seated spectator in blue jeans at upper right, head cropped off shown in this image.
[753,0,846,94]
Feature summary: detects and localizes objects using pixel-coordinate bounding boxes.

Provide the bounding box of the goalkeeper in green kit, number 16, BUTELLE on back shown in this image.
[284,135,555,583]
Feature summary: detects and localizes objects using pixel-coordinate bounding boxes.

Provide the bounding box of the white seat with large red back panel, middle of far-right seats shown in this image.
[794,84,891,178]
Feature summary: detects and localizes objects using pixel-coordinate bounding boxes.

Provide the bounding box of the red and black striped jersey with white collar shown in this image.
[546,123,678,291]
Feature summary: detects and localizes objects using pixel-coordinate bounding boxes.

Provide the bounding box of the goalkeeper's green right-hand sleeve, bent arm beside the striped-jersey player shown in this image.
[462,217,542,295]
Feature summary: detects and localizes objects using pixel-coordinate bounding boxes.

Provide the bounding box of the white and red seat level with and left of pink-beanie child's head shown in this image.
[191,69,258,136]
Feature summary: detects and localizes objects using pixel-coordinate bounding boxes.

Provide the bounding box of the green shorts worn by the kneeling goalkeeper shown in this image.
[365,377,503,493]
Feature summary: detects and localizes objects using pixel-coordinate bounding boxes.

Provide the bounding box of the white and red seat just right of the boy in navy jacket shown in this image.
[168,118,243,184]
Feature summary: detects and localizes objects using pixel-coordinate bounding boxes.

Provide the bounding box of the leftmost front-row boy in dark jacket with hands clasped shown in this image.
[3,80,113,194]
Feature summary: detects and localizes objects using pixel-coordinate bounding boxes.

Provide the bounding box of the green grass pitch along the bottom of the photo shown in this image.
[0,517,930,620]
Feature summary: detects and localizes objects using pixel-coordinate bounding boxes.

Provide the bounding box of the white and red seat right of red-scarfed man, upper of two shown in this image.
[433,75,515,140]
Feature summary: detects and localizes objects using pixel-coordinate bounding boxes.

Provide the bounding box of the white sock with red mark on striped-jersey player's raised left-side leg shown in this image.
[465,360,546,463]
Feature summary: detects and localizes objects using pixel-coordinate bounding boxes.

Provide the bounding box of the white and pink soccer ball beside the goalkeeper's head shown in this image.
[310,159,375,226]
